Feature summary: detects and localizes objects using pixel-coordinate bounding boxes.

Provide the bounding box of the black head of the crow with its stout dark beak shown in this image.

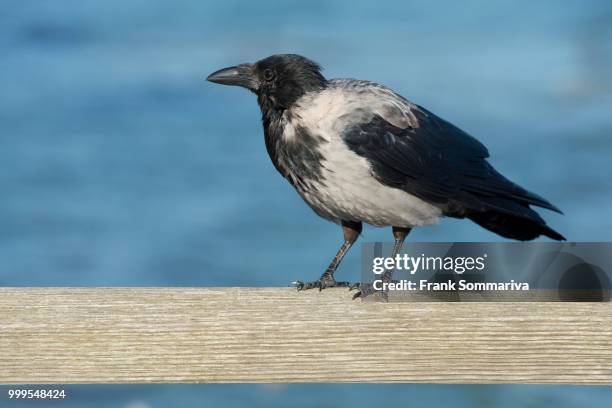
[206,54,327,110]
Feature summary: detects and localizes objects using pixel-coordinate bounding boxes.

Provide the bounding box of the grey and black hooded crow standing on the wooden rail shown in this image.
[207,54,565,290]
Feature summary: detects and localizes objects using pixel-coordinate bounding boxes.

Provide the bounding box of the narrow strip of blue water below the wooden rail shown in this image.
[0,384,610,408]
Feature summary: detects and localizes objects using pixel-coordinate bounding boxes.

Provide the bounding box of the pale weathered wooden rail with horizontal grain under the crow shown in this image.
[0,288,612,384]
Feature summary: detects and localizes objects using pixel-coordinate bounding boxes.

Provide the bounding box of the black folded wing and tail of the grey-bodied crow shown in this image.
[343,105,563,240]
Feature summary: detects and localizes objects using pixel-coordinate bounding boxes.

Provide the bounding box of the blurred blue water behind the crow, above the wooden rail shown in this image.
[0,0,612,406]
